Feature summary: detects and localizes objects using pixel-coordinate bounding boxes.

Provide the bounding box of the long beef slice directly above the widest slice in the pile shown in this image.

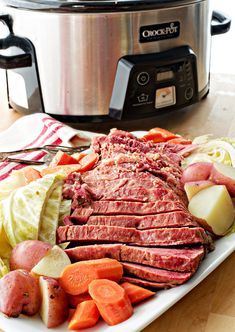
[71,211,198,230]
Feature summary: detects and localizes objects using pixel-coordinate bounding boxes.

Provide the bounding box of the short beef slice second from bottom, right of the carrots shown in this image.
[122,263,193,285]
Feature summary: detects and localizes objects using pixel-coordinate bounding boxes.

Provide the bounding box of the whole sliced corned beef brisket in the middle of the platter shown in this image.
[57,129,213,288]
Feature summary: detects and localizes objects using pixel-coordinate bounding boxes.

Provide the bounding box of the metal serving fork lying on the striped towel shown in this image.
[0,144,89,165]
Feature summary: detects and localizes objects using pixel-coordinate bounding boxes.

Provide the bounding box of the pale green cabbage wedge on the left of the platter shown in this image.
[1,174,62,247]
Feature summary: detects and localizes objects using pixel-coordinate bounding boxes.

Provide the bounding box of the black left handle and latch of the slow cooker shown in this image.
[0,15,32,69]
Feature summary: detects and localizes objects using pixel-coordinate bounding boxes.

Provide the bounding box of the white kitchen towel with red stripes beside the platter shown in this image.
[0,113,94,181]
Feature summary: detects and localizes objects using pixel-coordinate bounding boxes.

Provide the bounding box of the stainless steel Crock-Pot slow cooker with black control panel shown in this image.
[0,0,231,121]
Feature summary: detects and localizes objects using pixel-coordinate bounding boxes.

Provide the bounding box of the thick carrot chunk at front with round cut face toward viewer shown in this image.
[89,279,133,325]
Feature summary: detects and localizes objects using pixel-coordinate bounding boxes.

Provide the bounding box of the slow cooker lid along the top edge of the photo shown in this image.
[0,0,205,12]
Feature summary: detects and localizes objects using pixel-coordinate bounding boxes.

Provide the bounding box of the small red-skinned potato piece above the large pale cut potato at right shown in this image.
[181,162,213,184]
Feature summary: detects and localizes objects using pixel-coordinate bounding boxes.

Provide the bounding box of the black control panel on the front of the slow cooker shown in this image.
[109,46,198,120]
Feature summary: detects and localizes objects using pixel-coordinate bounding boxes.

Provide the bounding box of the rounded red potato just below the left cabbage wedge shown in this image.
[10,240,52,271]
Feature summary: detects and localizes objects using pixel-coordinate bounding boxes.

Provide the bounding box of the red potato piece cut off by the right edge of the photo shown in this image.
[210,163,235,197]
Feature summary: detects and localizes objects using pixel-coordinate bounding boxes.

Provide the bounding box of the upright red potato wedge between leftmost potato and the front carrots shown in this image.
[39,277,69,328]
